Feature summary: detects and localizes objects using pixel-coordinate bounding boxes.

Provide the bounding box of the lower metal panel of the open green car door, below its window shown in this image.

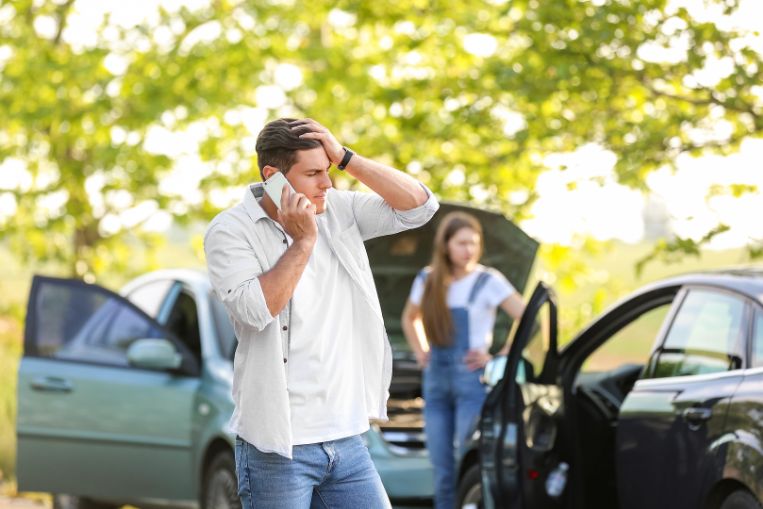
[17,358,199,500]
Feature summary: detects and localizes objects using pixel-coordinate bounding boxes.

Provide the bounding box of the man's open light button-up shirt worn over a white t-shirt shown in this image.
[204,183,439,458]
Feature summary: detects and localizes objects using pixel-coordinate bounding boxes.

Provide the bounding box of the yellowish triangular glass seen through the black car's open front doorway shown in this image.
[580,303,670,373]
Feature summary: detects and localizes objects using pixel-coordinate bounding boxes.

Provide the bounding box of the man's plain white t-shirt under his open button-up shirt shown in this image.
[286,216,369,445]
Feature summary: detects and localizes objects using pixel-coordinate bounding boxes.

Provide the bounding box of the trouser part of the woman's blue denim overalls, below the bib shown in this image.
[423,358,487,509]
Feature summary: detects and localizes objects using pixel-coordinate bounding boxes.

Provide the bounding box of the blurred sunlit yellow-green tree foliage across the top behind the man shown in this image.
[0,0,763,277]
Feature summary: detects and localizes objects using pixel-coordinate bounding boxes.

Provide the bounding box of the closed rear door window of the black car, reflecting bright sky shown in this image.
[652,290,745,378]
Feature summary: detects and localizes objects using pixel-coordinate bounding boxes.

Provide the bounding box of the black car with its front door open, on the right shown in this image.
[459,269,763,509]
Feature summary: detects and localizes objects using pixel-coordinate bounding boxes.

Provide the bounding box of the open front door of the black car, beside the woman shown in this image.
[480,283,569,509]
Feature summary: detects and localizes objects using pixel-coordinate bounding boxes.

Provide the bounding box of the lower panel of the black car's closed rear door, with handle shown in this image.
[616,372,742,509]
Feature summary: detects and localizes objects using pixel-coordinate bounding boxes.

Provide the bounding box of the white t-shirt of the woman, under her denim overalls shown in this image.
[408,265,516,351]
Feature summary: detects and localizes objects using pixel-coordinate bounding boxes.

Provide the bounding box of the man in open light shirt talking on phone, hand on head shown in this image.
[204,118,439,509]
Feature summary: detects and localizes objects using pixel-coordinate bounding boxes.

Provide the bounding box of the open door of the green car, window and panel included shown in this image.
[17,276,200,500]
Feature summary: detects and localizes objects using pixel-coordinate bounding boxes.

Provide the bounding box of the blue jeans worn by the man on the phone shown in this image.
[236,435,391,509]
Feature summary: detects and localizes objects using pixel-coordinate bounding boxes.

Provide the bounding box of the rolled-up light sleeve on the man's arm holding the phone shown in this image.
[204,223,273,331]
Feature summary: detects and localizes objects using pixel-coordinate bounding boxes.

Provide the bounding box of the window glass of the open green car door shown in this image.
[30,283,164,366]
